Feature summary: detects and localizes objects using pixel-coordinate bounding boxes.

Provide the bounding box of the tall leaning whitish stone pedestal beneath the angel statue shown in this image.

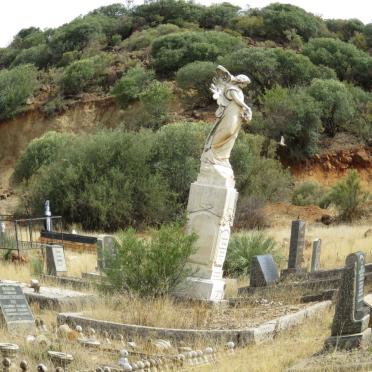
[177,163,238,301]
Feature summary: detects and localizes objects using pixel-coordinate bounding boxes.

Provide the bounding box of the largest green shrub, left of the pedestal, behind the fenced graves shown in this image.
[25,130,177,231]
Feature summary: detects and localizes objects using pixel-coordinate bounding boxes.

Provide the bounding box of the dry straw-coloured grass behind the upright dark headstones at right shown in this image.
[266,225,372,269]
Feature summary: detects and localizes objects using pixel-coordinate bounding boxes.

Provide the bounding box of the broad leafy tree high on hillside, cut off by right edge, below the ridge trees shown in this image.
[304,38,372,89]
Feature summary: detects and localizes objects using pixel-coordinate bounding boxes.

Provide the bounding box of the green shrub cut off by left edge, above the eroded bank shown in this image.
[0,65,38,120]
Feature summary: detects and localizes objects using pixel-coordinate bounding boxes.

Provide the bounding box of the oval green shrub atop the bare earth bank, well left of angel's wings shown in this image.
[112,65,155,107]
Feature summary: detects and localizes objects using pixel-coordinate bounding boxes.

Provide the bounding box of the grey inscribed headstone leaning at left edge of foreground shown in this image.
[0,284,35,330]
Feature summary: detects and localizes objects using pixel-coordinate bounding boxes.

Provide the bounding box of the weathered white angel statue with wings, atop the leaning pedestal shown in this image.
[201,66,252,168]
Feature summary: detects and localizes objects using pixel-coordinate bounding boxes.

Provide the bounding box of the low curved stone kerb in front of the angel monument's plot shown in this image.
[57,301,332,346]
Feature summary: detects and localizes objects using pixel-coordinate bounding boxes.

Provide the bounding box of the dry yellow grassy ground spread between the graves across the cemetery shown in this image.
[0,224,372,371]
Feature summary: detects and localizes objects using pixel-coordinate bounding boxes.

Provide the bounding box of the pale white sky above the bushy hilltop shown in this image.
[0,0,372,47]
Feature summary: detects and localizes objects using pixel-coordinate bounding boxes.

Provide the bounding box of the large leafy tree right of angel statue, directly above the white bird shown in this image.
[261,86,322,160]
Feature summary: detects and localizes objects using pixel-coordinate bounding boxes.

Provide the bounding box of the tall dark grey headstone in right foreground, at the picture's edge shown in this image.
[325,252,371,349]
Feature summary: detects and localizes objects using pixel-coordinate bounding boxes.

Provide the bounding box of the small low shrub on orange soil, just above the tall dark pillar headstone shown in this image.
[292,181,326,207]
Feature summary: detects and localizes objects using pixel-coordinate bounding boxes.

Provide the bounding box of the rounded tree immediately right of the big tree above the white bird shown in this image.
[308,79,355,136]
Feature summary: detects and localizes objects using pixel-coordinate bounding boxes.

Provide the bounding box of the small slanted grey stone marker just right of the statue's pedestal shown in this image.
[250,254,279,287]
